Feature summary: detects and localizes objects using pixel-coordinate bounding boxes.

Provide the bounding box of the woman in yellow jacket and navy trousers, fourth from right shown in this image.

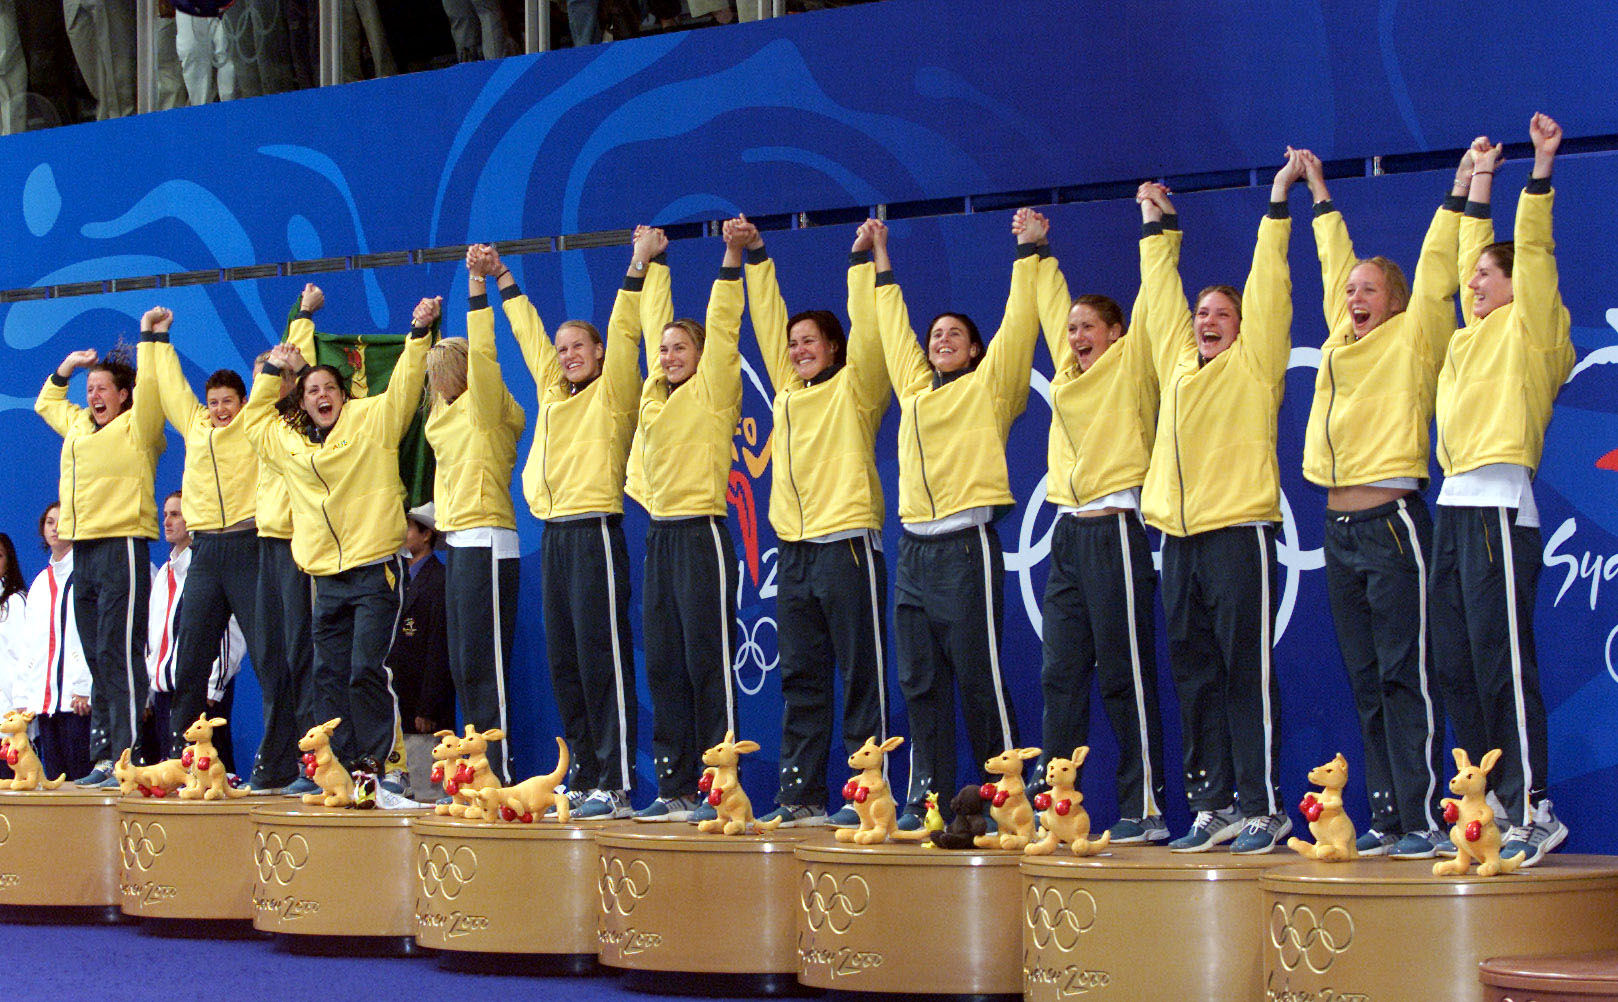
[1024,212,1180,845]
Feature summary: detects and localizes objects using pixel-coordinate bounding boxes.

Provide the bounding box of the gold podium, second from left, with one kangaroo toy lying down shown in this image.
[116,796,275,931]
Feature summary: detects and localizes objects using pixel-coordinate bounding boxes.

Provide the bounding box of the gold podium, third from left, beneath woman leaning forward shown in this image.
[251,801,427,955]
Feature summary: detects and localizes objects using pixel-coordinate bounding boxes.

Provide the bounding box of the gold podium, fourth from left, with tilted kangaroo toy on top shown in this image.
[411,814,621,974]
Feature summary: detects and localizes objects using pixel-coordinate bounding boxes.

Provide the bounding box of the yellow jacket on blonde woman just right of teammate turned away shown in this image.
[500,264,653,518]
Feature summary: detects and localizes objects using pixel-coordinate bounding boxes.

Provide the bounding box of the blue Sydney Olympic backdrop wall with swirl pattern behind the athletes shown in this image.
[0,0,1618,851]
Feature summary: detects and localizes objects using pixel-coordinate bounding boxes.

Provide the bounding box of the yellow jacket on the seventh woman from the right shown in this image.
[626,264,743,518]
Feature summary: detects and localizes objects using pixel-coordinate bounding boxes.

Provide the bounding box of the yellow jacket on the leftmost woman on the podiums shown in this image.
[34,340,168,541]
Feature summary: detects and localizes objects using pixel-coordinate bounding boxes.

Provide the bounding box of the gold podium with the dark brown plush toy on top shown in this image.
[793,843,1023,996]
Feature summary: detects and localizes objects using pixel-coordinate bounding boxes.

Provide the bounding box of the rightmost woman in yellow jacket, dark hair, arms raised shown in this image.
[1432,115,1574,866]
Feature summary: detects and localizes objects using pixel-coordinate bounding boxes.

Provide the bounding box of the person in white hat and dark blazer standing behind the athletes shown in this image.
[388,502,455,800]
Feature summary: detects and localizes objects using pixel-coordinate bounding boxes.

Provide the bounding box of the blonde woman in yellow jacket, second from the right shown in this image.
[1304,151,1472,860]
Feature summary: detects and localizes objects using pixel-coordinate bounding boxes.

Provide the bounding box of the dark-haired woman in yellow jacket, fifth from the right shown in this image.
[870,213,1039,830]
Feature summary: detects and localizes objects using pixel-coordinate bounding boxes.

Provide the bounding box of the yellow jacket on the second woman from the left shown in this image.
[152,333,259,533]
